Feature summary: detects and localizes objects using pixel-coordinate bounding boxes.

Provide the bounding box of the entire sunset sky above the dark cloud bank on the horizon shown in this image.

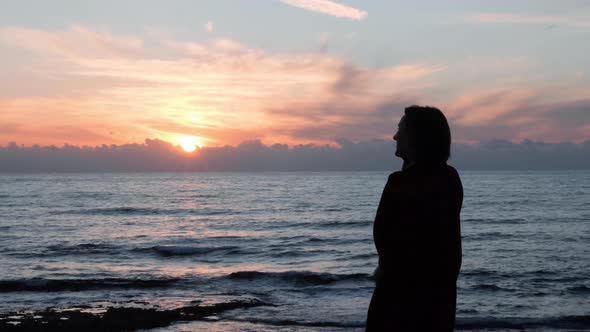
[0,0,590,147]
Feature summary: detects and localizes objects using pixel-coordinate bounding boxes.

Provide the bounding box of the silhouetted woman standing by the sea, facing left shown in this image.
[366,106,463,332]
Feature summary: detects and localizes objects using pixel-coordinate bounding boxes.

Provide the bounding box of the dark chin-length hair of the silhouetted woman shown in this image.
[405,105,451,163]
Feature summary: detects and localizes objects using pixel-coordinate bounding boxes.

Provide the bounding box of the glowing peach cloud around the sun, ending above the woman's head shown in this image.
[0,26,443,145]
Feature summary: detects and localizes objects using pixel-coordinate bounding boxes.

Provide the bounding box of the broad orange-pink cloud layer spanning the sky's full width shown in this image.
[0,26,590,146]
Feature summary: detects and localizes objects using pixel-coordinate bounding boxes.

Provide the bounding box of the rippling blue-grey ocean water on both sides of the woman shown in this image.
[0,171,590,331]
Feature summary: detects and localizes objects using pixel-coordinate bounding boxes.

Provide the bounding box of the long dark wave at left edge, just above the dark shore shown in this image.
[0,278,179,293]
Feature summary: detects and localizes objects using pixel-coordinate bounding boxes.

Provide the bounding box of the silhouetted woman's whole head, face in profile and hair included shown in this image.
[393,106,451,163]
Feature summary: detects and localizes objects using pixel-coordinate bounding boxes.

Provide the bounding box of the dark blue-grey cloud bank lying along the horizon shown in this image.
[0,139,590,172]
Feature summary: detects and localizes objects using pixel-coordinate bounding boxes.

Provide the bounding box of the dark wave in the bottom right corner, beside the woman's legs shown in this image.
[455,315,590,330]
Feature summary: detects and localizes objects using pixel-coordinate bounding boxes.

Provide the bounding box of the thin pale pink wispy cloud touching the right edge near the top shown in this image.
[466,13,590,28]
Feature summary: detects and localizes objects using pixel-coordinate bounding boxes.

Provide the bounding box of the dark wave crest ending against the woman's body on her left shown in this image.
[228,271,372,285]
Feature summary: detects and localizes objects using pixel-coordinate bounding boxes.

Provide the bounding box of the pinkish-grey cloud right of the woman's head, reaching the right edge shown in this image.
[443,88,590,142]
